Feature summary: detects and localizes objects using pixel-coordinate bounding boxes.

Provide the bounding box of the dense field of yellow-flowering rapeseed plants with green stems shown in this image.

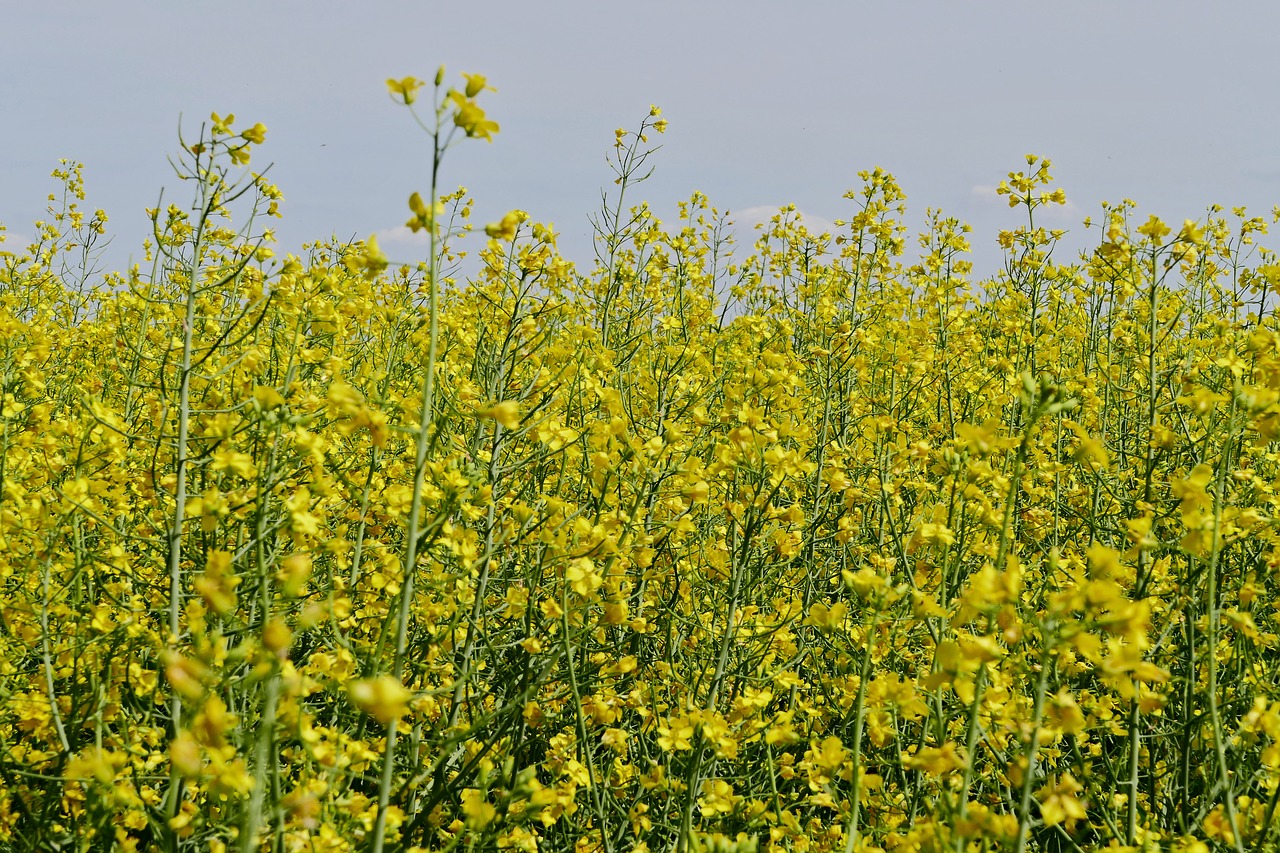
[0,69,1280,853]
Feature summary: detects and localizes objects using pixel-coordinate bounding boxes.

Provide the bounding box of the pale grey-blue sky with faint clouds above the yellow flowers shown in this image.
[0,0,1280,278]
